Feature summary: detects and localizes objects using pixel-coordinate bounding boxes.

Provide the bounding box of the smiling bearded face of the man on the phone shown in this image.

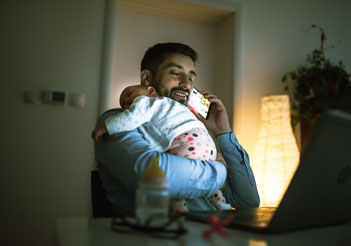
[151,55,196,105]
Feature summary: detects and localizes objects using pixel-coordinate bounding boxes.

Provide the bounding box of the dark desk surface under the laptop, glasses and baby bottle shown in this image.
[56,218,351,246]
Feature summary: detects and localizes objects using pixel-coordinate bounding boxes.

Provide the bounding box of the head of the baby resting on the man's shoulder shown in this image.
[119,85,159,109]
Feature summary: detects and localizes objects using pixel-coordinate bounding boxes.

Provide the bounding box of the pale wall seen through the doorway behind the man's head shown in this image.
[111,9,215,107]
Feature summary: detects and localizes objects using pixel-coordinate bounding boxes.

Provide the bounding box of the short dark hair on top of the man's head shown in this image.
[141,43,198,74]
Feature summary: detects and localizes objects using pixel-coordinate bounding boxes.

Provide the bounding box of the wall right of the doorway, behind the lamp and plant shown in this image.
[235,0,351,157]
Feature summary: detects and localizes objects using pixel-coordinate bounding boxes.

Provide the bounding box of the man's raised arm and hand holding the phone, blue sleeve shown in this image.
[194,92,260,208]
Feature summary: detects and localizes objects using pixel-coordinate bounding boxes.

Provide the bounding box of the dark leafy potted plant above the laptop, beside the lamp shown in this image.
[282,25,351,151]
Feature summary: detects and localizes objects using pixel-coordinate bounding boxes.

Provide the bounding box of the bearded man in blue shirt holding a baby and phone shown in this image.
[95,43,259,214]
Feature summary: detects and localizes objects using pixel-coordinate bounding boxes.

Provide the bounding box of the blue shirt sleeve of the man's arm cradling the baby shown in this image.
[95,111,227,199]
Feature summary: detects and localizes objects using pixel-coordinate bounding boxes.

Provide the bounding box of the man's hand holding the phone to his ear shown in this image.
[191,91,232,136]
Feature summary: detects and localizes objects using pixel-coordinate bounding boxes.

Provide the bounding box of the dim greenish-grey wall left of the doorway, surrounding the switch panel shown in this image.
[0,0,104,245]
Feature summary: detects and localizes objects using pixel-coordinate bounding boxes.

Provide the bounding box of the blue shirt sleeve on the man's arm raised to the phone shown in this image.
[217,132,260,208]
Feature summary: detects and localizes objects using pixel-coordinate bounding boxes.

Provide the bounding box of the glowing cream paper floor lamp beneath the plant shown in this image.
[252,95,299,207]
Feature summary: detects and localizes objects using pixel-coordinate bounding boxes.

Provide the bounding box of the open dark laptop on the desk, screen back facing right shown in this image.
[185,110,351,233]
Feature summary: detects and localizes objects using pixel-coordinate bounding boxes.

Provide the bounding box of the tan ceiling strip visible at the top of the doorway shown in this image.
[117,0,232,24]
